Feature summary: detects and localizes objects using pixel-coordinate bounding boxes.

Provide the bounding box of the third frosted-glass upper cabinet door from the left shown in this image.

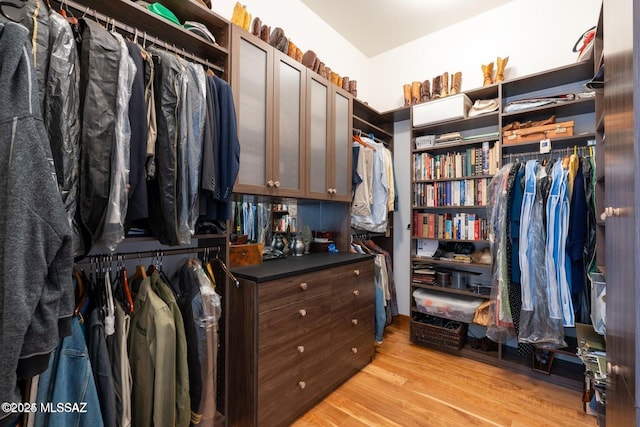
[307,73,331,199]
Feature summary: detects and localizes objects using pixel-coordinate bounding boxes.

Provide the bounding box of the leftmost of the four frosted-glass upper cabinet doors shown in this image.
[231,26,273,194]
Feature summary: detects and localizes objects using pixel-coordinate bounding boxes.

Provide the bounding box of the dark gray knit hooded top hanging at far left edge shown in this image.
[0,22,74,424]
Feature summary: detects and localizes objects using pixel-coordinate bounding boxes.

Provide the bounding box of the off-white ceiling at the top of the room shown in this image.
[301,0,512,58]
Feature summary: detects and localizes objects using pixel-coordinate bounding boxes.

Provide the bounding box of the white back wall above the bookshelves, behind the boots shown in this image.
[368,0,602,111]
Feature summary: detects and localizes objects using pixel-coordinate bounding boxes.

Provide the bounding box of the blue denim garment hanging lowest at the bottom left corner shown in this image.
[34,317,103,427]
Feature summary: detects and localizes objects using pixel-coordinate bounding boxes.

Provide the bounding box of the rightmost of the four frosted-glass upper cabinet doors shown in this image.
[330,86,353,202]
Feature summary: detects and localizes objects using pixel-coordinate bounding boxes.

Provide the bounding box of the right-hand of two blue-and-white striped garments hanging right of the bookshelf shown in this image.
[545,160,575,326]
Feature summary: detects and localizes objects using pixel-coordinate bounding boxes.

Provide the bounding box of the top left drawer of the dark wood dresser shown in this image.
[258,270,332,312]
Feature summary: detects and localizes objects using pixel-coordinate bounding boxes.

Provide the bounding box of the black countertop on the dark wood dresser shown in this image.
[231,252,373,282]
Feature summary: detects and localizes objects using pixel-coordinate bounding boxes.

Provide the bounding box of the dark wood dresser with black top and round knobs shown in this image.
[227,253,375,427]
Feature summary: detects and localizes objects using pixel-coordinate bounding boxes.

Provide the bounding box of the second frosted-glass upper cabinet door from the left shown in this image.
[270,52,306,197]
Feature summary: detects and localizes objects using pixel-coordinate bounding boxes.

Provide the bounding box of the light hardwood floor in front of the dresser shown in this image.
[293,317,597,427]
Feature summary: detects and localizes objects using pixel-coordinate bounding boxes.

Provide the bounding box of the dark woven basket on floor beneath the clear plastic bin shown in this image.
[409,313,468,350]
